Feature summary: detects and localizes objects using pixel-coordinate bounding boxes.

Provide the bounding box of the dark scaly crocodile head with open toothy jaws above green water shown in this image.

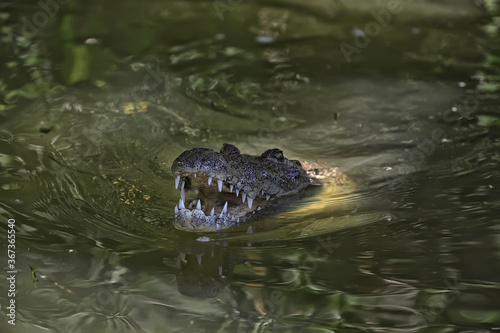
[172,144,312,231]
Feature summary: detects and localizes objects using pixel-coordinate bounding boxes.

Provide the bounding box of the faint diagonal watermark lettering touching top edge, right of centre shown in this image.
[339,0,403,64]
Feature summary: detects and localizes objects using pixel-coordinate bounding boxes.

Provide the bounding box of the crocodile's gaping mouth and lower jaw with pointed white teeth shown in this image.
[174,171,276,232]
